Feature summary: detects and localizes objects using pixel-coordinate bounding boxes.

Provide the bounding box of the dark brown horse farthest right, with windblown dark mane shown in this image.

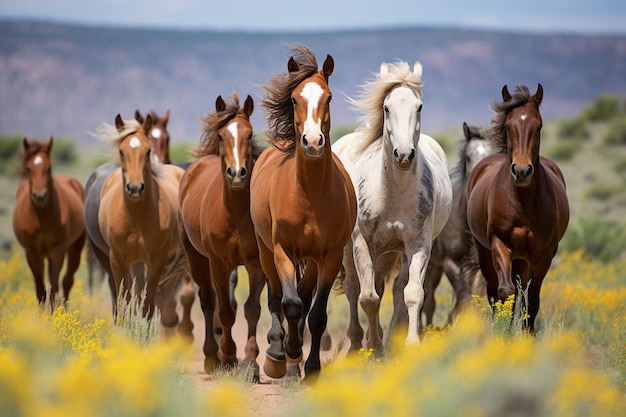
[467,84,569,333]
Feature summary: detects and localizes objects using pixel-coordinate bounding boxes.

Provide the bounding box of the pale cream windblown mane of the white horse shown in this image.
[348,61,423,155]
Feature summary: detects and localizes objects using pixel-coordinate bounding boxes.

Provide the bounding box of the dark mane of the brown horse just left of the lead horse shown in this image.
[191,92,263,160]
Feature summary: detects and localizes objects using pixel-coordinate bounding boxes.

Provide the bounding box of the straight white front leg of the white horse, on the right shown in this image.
[404,241,431,344]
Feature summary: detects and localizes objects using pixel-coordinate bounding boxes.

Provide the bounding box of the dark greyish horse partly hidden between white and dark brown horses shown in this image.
[422,122,495,326]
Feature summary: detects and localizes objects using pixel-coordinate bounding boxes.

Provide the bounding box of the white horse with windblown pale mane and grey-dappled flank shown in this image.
[333,62,452,355]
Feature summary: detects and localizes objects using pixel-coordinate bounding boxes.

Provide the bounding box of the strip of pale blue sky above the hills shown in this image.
[0,0,626,34]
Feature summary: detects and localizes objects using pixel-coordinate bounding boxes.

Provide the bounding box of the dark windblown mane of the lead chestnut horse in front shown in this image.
[261,45,319,155]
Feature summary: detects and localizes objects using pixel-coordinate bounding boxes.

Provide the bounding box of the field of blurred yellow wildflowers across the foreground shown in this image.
[0,247,626,417]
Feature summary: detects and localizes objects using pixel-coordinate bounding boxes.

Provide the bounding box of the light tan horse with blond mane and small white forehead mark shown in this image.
[94,114,191,335]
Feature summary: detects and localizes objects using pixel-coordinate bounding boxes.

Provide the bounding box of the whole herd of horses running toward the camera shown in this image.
[13,45,569,379]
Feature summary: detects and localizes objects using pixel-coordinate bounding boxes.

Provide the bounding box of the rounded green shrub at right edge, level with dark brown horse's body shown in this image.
[560,217,626,263]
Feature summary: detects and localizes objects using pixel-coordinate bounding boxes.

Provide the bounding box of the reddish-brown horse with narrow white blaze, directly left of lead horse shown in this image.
[179,93,265,380]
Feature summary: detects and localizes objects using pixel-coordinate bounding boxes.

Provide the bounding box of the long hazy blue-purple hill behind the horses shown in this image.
[0,21,626,144]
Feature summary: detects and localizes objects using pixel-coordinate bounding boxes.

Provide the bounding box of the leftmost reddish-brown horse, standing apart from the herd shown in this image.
[13,137,85,311]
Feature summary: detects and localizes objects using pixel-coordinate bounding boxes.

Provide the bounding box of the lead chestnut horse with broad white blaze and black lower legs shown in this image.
[250,45,356,380]
